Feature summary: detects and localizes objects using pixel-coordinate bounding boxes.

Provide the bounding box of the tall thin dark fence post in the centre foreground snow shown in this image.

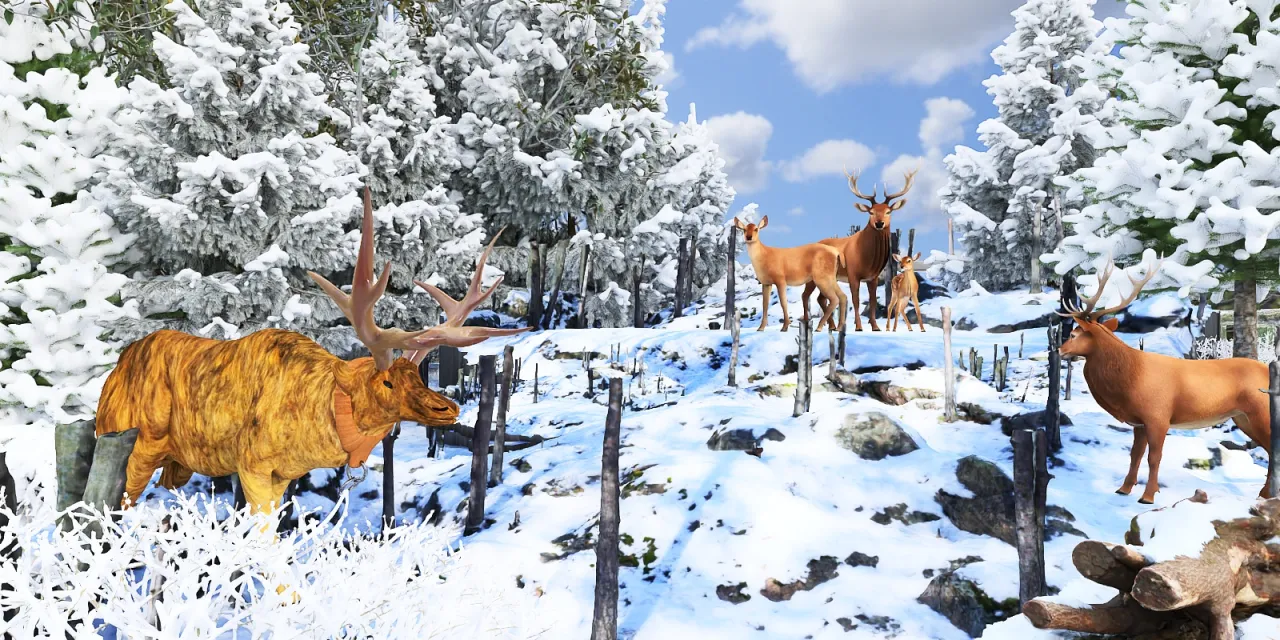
[591,378,622,640]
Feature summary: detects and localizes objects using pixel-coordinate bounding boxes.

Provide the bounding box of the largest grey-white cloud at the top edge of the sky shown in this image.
[686,0,1024,92]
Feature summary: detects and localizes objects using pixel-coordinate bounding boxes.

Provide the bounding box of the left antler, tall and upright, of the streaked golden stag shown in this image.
[307,187,424,371]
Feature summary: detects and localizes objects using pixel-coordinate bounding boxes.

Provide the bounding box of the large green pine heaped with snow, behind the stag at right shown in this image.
[1053,0,1280,357]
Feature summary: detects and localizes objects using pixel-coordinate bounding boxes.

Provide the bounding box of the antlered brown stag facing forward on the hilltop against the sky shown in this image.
[804,170,915,332]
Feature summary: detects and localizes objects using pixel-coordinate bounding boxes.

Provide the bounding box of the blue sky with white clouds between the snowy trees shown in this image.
[663,0,1124,255]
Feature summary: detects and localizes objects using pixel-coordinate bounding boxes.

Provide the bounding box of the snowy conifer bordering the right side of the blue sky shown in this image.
[942,0,1105,291]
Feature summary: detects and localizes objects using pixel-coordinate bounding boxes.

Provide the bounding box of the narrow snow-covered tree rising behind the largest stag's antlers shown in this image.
[338,15,488,326]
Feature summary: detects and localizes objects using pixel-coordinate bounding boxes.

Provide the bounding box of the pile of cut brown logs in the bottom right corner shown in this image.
[1023,492,1280,640]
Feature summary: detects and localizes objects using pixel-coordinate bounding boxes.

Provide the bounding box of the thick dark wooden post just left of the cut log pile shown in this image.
[1012,429,1048,604]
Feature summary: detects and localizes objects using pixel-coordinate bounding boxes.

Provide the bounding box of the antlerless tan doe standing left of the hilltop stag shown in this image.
[733,216,847,332]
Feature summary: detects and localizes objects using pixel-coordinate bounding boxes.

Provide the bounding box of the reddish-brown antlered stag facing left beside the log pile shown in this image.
[1059,261,1271,504]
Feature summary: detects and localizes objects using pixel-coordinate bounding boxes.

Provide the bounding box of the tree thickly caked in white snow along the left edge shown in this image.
[0,0,133,430]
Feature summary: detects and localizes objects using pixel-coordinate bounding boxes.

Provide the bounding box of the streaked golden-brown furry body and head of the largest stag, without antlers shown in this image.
[97,329,458,511]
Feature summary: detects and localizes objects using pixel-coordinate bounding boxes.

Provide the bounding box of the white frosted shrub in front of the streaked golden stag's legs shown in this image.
[0,495,545,639]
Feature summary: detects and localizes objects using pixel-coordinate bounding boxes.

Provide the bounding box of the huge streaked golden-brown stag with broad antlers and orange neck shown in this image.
[96,188,529,512]
